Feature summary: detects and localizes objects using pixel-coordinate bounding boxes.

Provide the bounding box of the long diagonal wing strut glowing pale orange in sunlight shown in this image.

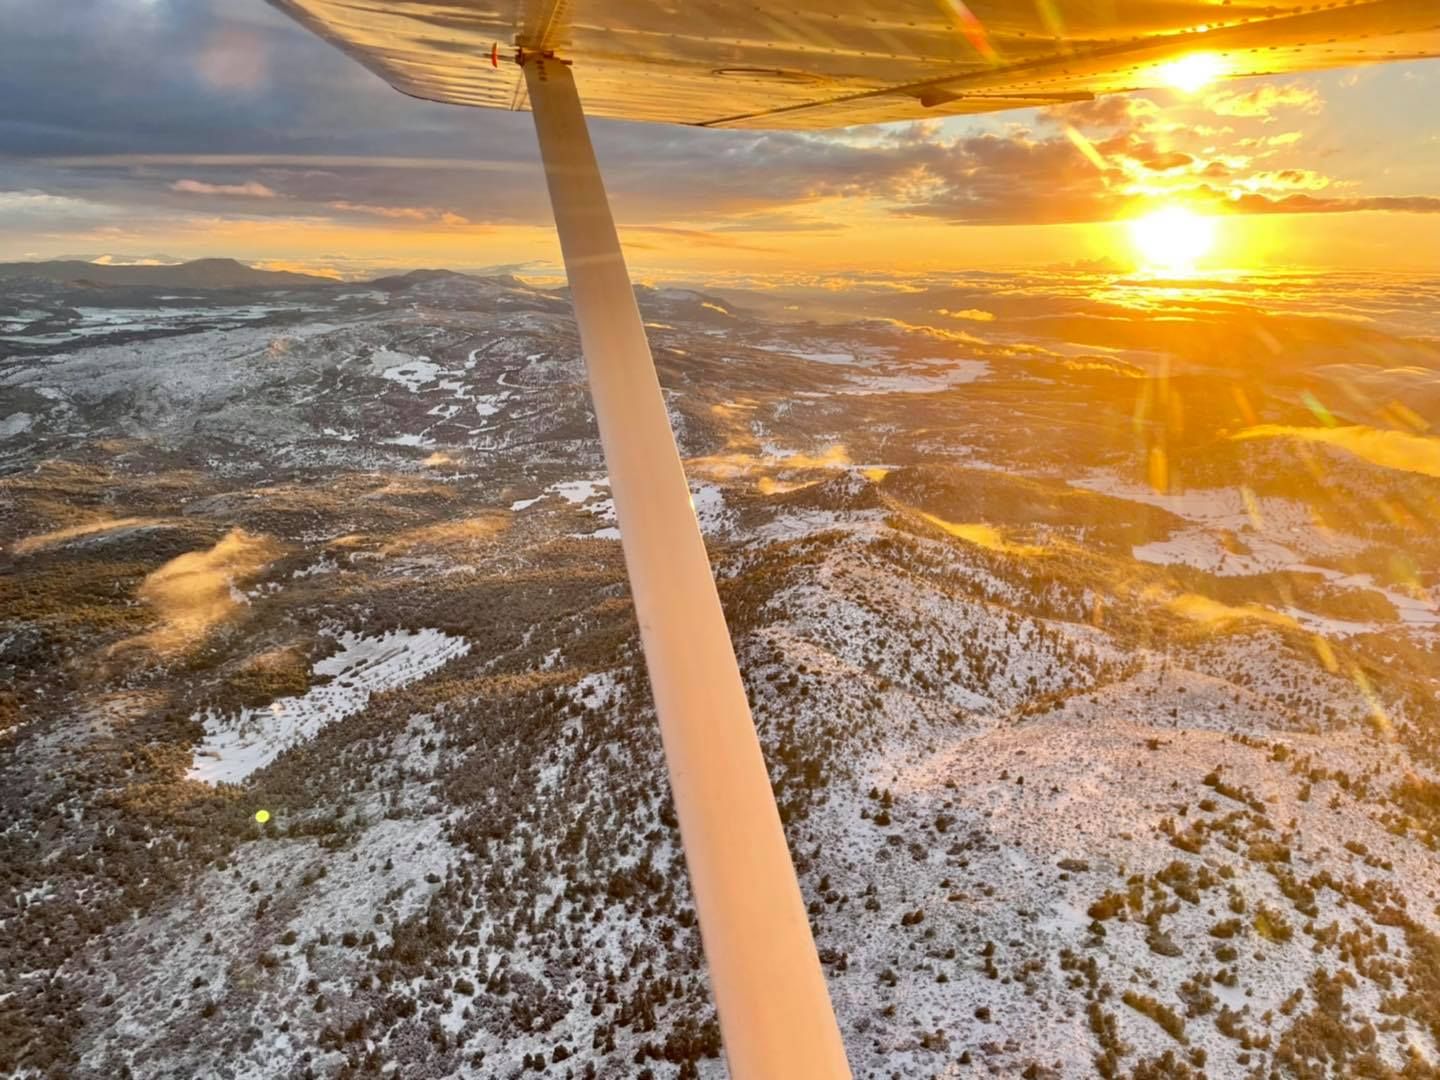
[523,55,850,1080]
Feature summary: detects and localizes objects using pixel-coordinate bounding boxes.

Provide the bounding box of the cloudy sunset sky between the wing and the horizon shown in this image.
[0,0,1440,278]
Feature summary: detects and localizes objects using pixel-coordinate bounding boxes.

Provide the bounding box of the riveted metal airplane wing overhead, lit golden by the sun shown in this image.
[271,0,1440,128]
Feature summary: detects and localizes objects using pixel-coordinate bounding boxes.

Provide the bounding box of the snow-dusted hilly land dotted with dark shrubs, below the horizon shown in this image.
[0,264,1440,1079]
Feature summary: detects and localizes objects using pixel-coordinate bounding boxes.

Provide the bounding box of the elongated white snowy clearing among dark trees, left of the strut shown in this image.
[189,629,469,783]
